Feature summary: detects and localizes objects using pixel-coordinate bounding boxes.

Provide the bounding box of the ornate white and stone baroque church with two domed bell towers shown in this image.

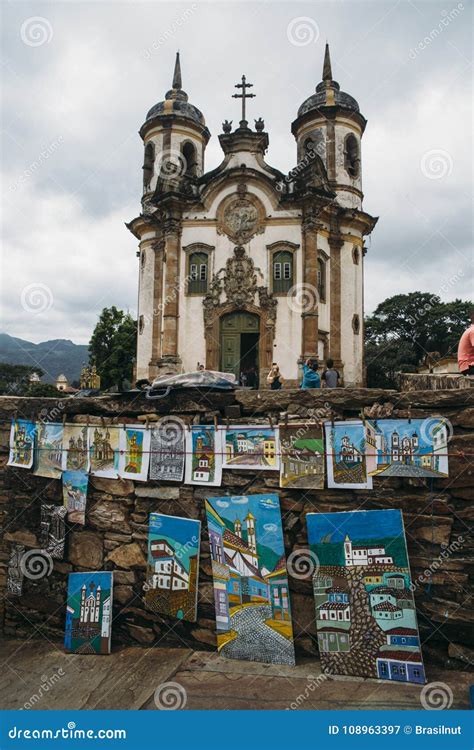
[127,45,377,388]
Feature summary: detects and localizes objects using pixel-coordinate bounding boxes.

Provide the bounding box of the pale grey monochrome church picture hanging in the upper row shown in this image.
[150,417,186,482]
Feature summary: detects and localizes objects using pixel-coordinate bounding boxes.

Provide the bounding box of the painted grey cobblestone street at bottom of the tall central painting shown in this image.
[220,605,295,665]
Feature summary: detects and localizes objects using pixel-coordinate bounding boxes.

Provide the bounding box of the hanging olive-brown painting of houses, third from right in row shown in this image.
[280,424,325,490]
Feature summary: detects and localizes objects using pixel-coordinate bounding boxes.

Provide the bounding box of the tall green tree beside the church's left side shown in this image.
[89,306,137,390]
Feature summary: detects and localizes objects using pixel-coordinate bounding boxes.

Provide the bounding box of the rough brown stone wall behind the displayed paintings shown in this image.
[0,389,474,676]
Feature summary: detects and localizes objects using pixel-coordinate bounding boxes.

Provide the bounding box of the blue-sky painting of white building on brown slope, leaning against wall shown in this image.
[145,513,201,622]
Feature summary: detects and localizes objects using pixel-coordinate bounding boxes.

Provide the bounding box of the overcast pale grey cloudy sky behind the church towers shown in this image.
[0,0,473,343]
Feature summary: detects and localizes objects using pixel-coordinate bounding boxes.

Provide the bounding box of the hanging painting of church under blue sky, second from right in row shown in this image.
[324,419,372,489]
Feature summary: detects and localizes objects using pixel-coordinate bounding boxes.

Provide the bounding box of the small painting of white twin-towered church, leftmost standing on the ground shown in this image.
[64,571,113,654]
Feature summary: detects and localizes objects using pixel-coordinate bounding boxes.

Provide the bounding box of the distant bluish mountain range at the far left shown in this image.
[0,333,89,383]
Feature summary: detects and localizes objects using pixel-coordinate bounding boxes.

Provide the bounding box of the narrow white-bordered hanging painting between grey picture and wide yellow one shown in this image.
[184,425,224,487]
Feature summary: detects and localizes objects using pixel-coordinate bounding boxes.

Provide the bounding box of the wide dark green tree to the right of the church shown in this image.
[365,292,472,388]
